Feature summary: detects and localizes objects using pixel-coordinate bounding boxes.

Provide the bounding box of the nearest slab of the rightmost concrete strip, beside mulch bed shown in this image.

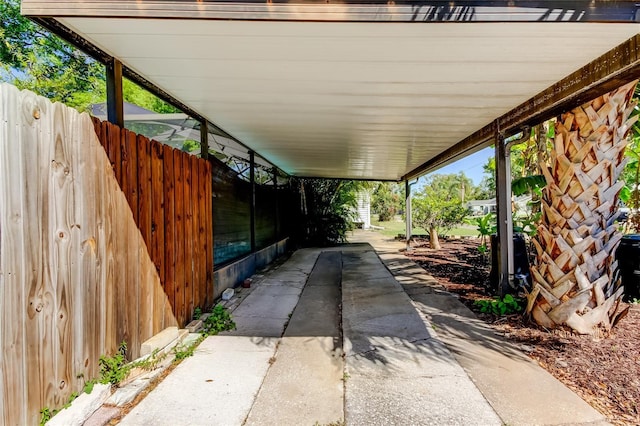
[414,295,607,425]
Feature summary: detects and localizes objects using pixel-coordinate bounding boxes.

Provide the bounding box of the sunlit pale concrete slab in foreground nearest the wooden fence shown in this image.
[120,335,277,426]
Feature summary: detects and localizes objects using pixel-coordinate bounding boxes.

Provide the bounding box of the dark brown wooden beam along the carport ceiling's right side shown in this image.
[402,35,640,180]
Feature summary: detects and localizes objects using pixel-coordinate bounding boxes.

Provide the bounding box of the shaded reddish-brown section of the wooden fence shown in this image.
[93,118,214,326]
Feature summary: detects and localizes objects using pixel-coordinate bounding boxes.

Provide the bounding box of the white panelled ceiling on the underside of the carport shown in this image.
[57,17,640,179]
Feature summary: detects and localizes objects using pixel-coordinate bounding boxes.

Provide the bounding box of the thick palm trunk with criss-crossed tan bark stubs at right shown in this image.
[527,82,637,334]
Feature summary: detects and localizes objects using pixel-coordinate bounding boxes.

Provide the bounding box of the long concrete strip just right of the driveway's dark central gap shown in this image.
[342,246,501,425]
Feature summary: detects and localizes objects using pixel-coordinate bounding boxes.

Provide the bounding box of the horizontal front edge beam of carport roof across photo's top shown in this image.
[22,0,640,22]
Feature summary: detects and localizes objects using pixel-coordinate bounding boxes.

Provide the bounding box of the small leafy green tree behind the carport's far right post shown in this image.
[412,173,475,250]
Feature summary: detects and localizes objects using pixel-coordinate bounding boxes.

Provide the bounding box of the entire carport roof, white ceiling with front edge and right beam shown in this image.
[23,0,640,180]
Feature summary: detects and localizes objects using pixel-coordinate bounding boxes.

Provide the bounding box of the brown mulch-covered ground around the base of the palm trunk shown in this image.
[409,239,640,425]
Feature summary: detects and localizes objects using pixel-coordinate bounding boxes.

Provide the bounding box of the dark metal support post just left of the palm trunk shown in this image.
[495,131,513,296]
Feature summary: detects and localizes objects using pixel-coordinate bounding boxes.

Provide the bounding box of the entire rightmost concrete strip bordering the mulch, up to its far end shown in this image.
[357,233,607,425]
